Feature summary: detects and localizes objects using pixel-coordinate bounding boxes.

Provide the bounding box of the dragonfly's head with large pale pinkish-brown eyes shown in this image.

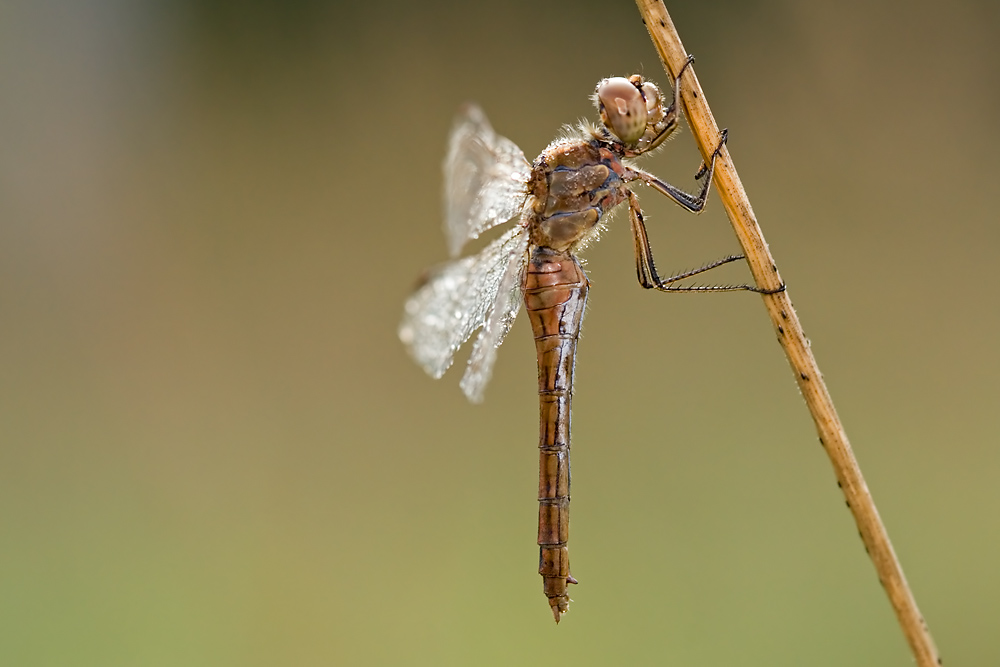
[594,74,673,155]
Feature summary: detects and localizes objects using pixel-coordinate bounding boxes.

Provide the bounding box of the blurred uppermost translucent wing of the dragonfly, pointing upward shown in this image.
[444,104,531,257]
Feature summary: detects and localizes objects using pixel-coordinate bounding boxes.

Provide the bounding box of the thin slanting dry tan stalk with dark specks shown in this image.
[636,0,941,667]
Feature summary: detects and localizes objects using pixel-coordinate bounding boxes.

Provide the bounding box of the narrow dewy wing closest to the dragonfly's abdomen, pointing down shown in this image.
[461,226,528,403]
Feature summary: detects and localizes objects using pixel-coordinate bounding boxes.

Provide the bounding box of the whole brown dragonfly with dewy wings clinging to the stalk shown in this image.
[399,57,783,623]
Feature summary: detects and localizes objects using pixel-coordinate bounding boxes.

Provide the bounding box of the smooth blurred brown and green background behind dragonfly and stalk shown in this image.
[0,0,1000,667]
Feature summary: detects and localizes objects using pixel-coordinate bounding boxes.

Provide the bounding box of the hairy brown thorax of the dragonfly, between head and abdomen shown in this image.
[528,139,627,252]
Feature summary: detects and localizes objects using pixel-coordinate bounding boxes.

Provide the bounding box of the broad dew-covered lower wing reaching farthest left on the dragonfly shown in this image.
[399,224,528,396]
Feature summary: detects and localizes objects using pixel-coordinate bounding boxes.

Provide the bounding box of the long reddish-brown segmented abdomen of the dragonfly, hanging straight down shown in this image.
[524,246,588,623]
